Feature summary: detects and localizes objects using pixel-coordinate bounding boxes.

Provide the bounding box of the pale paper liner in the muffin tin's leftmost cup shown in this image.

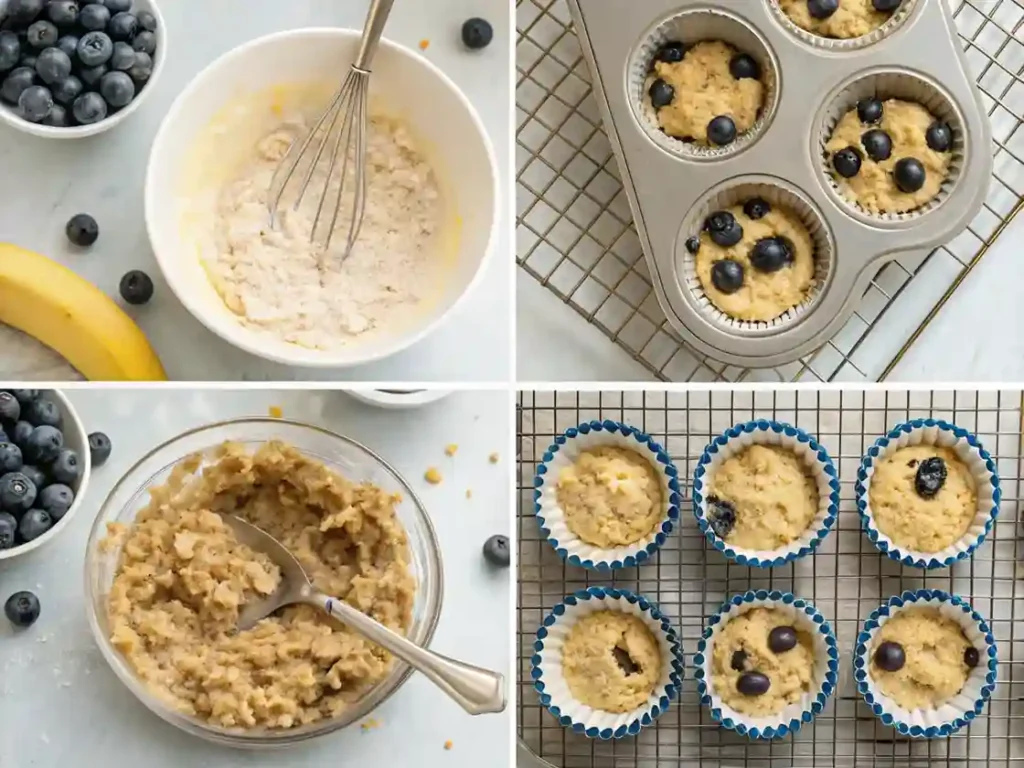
[626,8,779,161]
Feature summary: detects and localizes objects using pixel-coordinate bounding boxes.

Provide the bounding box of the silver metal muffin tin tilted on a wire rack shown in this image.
[568,0,992,368]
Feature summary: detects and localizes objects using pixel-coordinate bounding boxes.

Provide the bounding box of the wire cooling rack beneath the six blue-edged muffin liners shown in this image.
[517,390,1024,768]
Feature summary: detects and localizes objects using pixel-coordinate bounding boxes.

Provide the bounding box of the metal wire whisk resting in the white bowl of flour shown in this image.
[269,0,394,258]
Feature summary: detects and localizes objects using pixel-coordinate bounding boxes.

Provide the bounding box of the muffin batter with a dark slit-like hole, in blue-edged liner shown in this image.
[562,610,662,713]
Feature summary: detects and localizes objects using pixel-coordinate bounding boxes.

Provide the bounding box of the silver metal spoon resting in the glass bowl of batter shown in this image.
[222,515,506,715]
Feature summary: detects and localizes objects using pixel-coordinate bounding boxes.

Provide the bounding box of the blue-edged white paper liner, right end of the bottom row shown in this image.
[853,590,998,738]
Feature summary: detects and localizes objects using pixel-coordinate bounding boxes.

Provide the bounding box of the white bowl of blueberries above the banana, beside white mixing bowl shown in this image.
[0,0,166,138]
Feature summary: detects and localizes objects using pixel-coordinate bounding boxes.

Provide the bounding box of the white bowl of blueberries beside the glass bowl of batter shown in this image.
[0,389,97,561]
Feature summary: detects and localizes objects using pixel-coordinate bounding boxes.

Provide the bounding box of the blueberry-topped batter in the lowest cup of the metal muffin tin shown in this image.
[687,201,815,322]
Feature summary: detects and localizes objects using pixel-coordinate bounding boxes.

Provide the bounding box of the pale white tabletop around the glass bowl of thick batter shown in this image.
[0,388,512,768]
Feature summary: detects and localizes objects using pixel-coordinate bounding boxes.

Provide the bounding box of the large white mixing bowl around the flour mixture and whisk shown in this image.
[145,29,500,368]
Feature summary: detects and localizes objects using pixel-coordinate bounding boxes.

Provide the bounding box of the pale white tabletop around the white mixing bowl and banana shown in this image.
[0,0,512,381]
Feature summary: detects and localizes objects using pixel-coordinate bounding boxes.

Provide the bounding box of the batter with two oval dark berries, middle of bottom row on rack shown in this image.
[712,607,814,717]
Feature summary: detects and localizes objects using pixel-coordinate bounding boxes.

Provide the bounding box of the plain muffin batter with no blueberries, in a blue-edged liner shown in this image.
[555,445,665,547]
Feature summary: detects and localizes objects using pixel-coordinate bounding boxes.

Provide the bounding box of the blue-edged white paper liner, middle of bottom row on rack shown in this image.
[693,590,839,739]
